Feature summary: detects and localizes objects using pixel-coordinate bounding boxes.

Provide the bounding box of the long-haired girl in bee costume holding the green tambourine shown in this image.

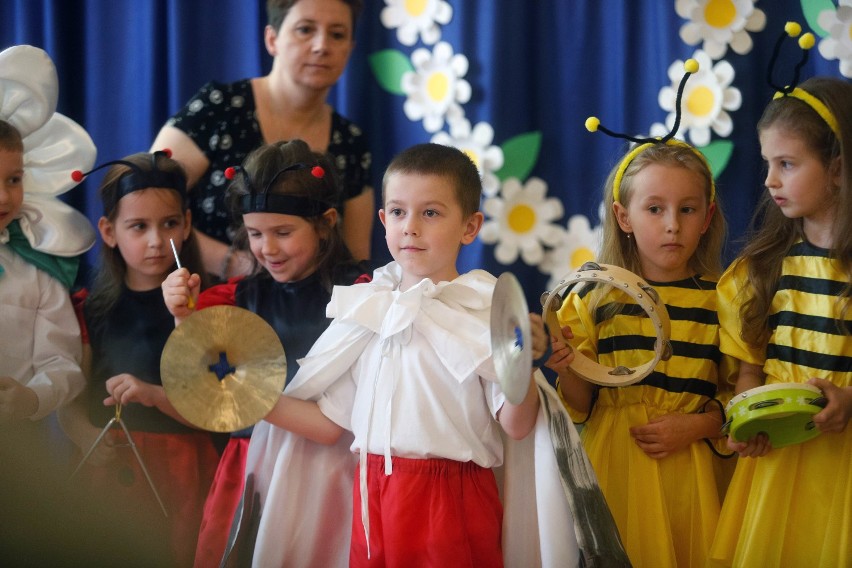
[708,22,852,567]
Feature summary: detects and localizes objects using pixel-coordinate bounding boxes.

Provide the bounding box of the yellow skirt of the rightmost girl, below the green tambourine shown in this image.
[708,428,852,568]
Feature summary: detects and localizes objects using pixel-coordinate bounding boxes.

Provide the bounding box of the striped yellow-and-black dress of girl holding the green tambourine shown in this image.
[712,242,852,567]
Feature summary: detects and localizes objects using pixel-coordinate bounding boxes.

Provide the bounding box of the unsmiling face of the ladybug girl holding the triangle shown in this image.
[98,188,192,291]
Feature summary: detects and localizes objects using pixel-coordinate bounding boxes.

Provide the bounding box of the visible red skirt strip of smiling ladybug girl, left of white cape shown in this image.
[195,438,250,568]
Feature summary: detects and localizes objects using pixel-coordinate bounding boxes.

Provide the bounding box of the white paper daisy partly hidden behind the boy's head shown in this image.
[431,118,503,197]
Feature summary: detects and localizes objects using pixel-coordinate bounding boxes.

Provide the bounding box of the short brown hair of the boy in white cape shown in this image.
[382,143,482,218]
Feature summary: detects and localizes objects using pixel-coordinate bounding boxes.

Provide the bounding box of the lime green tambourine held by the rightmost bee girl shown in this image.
[722,383,828,448]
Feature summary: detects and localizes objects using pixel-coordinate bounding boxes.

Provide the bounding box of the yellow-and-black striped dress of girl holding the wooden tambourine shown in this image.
[559,277,732,567]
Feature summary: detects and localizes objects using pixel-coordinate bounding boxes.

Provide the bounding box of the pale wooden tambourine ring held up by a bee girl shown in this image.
[541,262,672,387]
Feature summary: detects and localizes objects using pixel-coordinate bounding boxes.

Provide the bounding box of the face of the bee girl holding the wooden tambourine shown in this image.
[613,164,715,282]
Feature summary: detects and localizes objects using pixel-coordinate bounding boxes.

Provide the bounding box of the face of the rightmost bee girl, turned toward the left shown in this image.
[760,127,840,240]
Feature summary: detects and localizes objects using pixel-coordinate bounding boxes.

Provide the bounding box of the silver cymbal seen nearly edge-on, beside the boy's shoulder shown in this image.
[491,272,532,404]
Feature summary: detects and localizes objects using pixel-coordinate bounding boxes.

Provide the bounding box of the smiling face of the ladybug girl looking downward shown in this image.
[243,209,337,282]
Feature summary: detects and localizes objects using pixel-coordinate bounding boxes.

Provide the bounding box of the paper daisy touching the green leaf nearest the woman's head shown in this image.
[402,42,471,132]
